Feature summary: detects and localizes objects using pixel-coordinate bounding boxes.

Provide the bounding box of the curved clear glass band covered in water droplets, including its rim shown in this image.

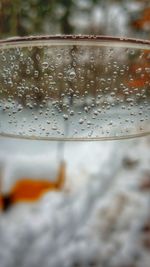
[0,36,150,140]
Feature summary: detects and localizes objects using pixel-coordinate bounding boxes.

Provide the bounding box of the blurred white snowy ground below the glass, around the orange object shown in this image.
[0,137,150,267]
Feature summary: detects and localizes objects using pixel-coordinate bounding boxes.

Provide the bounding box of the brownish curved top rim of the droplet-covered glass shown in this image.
[0,35,150,48]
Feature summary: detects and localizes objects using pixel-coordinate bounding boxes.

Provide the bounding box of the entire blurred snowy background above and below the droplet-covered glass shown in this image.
[0,0,150,267]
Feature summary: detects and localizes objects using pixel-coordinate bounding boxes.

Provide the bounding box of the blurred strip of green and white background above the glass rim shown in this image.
[0,0,150,39]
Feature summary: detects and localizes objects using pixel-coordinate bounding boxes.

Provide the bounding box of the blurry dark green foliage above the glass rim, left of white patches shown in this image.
[0,0,74,37]
